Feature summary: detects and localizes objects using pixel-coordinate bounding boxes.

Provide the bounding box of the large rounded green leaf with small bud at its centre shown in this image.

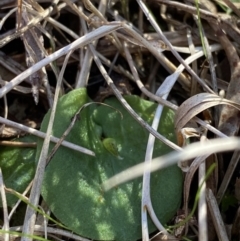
[38,89,182,241]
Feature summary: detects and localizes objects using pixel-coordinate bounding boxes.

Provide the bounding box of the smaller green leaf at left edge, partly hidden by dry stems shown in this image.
[0,136,36,207]
